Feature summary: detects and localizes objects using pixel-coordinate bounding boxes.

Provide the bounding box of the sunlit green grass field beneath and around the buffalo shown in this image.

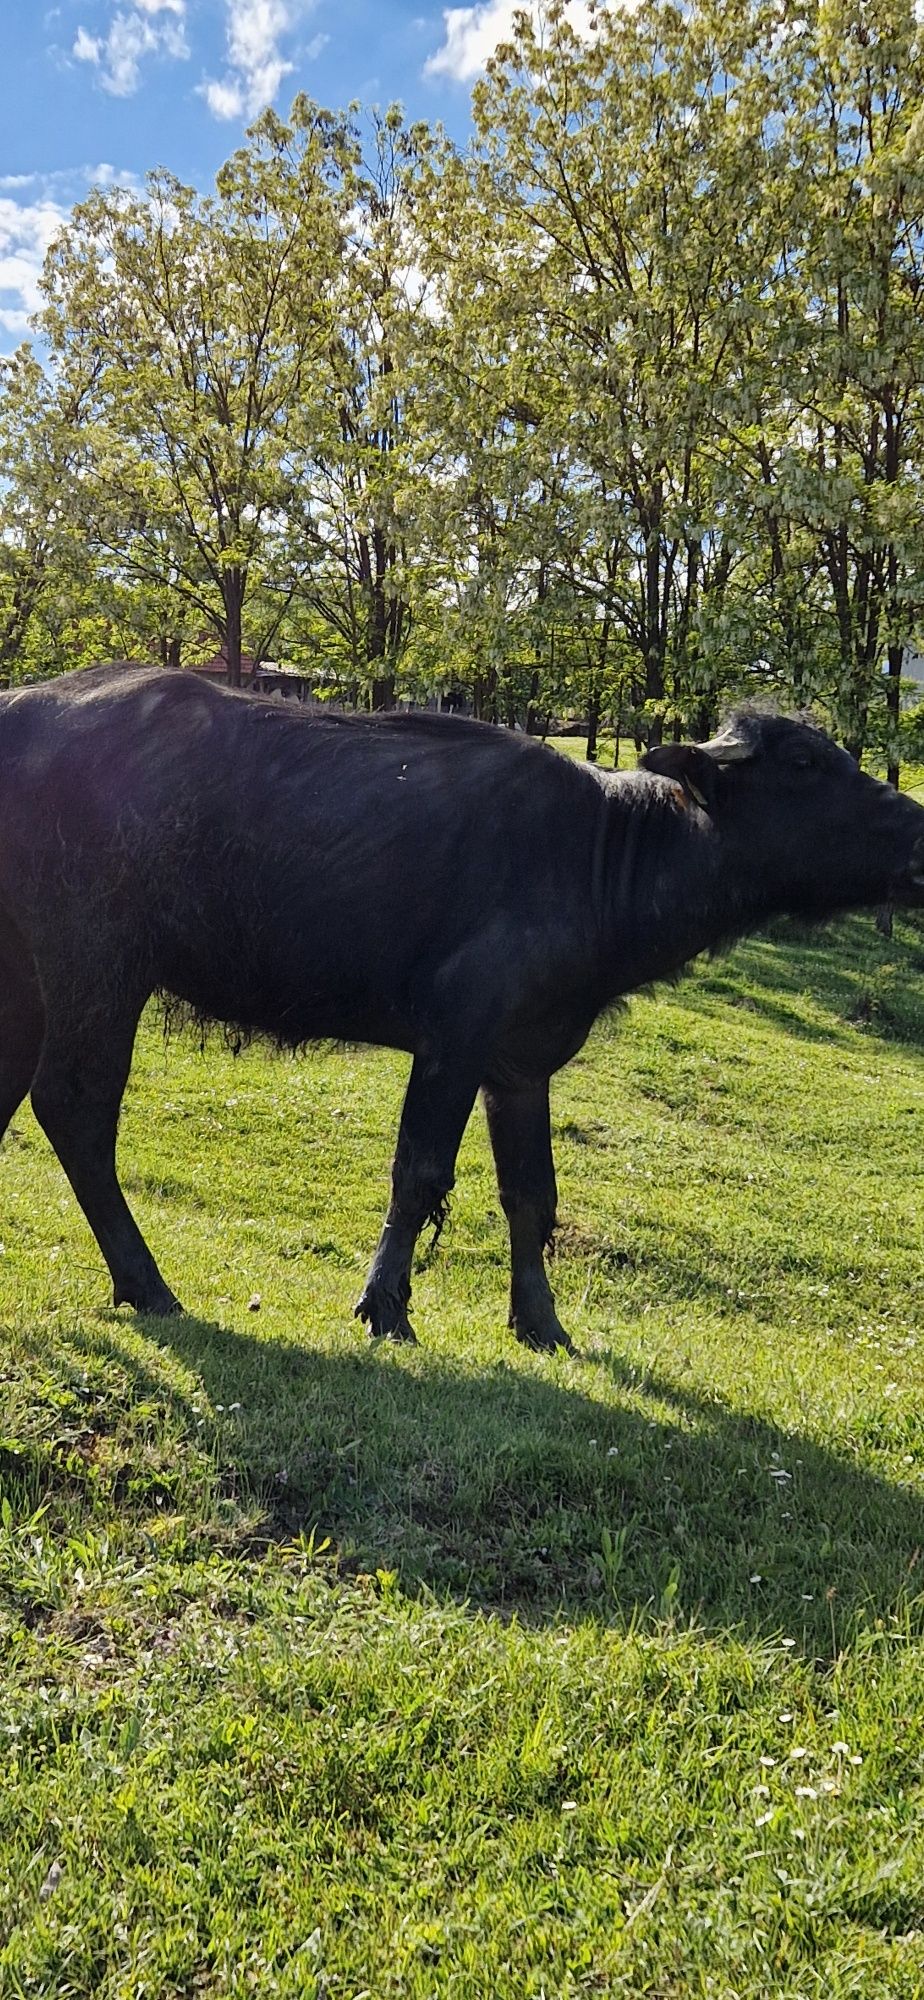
[0,920,924,2000]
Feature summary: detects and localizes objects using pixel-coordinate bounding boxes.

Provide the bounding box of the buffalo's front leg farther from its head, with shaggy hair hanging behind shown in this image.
[354,1056,478,1340]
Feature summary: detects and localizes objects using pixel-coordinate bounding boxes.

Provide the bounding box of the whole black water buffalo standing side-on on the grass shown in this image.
[0,666,924,1348]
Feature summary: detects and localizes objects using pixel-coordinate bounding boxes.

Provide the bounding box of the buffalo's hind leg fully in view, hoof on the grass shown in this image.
[32,998,182,1314]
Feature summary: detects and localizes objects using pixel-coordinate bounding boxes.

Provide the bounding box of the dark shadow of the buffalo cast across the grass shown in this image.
[25,1314,924,1660]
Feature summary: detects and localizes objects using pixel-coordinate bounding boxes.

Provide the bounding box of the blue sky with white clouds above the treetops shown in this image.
[0,0,536,352]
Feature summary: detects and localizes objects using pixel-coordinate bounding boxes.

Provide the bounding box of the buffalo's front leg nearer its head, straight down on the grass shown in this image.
[484,1084,574,1354]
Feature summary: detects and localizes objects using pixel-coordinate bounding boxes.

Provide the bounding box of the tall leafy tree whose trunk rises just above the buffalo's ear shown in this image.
[426,0,788,740]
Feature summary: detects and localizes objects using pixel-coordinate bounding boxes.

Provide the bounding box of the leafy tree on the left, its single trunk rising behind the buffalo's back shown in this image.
[40,98,352,684]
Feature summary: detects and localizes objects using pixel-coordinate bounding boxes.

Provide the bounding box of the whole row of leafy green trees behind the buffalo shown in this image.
[0,0,924,750]
